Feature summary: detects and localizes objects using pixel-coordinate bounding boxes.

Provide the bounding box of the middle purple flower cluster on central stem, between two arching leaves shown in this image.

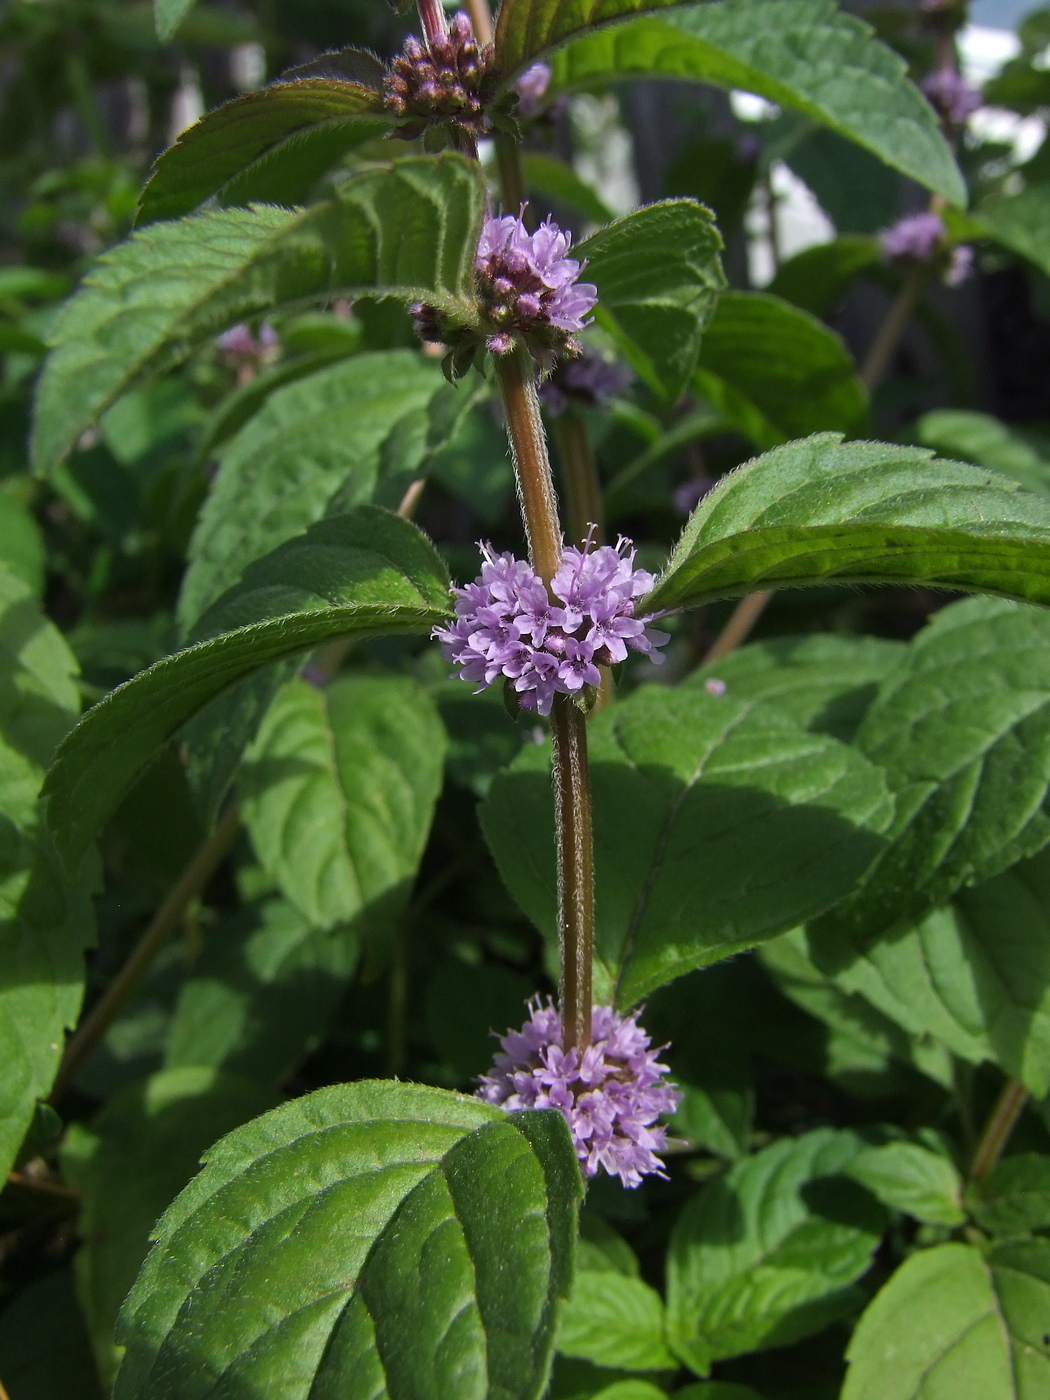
[434,536,668,714]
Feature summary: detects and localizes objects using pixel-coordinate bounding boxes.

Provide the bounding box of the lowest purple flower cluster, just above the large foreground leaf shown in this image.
[477,997,682,1187]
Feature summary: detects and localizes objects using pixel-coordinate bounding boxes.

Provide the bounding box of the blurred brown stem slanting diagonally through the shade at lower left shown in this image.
[48,804,241,1103]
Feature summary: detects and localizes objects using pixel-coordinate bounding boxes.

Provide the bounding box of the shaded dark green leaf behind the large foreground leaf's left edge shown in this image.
[62,1068,274,1386]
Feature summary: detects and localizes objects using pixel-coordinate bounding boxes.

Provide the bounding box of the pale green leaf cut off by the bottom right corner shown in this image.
[843,1240,1050,1400]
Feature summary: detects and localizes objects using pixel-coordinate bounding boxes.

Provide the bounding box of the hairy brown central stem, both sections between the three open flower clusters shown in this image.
[496,346,594,1050]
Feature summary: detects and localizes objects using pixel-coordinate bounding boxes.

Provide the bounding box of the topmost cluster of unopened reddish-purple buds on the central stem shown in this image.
[382,14,498,137]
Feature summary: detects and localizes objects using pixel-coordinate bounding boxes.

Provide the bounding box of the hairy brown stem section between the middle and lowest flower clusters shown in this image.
[550,694,594,1050]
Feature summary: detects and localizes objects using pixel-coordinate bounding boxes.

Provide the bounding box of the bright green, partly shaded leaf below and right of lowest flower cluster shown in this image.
[668,1128,883,1376]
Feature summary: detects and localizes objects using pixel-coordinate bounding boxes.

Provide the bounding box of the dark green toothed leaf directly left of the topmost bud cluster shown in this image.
[136,81,389,228]
